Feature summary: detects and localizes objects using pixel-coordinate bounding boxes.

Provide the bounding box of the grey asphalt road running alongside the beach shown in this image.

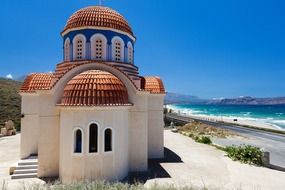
[167,114,285,168]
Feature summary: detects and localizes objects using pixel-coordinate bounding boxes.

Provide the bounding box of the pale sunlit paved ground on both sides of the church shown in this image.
[0,131,285,190]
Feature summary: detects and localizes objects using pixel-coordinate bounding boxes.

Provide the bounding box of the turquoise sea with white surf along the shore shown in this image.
[166,104,285,131]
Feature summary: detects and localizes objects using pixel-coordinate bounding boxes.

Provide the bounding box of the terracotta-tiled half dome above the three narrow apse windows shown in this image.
[60,70,131,106]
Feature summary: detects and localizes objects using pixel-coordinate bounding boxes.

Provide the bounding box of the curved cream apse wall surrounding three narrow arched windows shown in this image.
[60,107,129,182]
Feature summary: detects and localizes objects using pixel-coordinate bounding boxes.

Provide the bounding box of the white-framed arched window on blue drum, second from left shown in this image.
[73,35,86,60]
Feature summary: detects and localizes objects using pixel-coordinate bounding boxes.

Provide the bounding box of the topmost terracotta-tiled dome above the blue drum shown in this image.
[63,6,133,36]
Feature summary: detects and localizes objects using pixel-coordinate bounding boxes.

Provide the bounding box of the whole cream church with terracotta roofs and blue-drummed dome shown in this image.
[20,6,165,182]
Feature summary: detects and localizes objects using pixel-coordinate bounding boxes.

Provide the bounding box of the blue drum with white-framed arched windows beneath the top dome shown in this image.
[63,29,134,65]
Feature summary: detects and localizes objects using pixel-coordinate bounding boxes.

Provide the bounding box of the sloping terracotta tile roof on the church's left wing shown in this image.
[20,73,53,93]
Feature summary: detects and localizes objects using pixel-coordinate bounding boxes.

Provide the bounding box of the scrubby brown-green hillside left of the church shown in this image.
[0,78,22,126]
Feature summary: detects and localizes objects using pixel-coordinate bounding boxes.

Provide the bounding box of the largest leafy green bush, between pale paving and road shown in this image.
[225,145,263,166]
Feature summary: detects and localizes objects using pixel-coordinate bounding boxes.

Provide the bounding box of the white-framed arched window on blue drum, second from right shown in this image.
[112,37,125,62]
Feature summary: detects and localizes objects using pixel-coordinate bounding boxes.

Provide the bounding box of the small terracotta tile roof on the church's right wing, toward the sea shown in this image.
[141,77,165,94]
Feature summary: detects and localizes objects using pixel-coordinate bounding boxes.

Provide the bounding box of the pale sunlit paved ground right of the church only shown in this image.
[146,131,285,190]
